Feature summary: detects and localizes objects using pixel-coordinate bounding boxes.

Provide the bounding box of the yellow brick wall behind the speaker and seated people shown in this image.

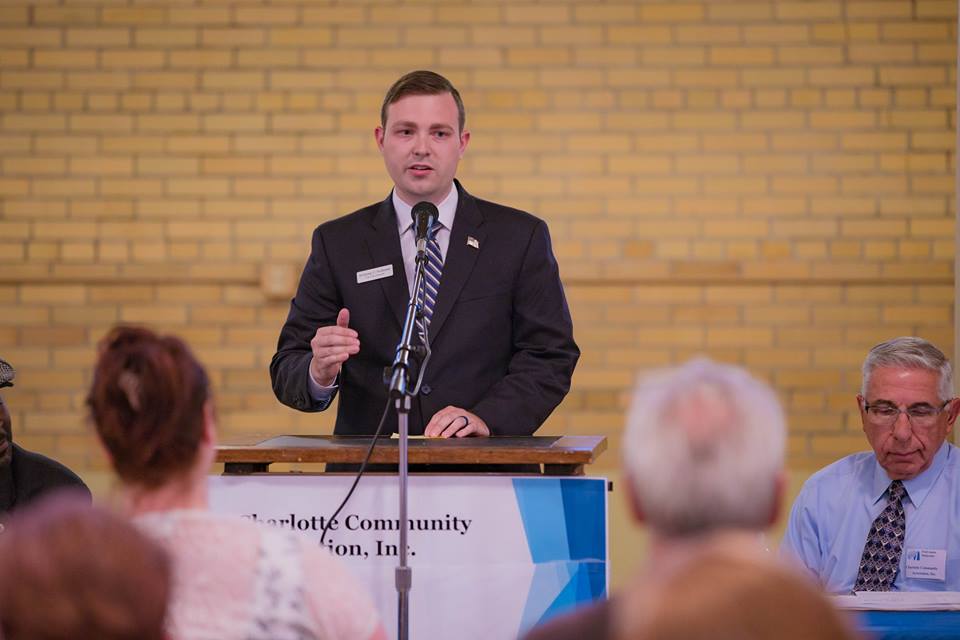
[0,0,957,480]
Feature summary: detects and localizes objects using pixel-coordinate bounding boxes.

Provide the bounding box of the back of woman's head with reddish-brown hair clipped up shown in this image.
[87,327,209,487]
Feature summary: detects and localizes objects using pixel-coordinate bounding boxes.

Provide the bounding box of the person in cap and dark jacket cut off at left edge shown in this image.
[0,360,91,516]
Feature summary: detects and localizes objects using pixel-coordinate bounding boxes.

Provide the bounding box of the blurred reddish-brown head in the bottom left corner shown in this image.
[0,494,171,640]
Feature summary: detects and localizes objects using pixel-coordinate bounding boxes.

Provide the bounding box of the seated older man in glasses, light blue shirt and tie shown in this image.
[781,338,960,593]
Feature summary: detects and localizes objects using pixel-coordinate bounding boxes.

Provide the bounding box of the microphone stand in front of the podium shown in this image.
[389,245,430,640]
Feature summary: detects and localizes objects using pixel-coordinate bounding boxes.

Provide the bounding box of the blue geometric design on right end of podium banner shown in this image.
[513,478,607,632]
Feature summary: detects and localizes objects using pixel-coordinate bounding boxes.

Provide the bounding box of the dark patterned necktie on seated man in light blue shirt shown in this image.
[853,480,907,591]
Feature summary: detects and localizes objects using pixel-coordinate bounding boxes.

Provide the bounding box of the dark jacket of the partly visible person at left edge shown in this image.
[0,444,92,513]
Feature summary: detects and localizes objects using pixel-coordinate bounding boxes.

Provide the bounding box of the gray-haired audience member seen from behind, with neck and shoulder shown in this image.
[525,358,786,640]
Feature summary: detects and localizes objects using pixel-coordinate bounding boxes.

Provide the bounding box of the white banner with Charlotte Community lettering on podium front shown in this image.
[210,474,609,640]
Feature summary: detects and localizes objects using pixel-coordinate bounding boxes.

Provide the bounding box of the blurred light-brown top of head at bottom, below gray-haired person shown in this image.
[618,541,857,640]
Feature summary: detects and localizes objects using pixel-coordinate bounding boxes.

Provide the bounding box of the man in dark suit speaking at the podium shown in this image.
[270,71,580,437]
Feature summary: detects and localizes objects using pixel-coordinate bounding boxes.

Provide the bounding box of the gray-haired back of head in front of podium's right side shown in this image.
[623,358,786,536]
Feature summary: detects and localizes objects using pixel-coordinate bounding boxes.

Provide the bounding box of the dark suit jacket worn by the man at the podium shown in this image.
[270,182,580,435]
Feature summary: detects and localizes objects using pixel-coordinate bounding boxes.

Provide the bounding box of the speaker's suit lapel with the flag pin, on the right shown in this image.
[430,182,485,342]
